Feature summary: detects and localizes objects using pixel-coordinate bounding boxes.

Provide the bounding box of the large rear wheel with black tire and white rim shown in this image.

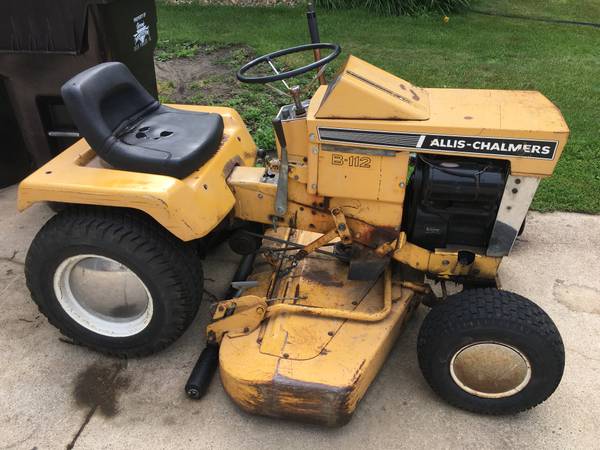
[25,207,203,356]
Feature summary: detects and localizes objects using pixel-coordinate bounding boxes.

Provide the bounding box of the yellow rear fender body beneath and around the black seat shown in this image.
[18,105,256,241]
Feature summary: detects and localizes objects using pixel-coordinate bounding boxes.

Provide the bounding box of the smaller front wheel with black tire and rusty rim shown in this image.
[417,288,565,414]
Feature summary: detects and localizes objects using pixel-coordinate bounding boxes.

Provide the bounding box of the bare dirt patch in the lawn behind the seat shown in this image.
[155,45,254,104]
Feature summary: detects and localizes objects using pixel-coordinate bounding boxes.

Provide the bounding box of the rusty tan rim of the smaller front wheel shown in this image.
[450,341,531,398]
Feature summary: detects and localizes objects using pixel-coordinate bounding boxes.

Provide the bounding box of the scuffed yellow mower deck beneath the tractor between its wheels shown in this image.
[220,232,417,426]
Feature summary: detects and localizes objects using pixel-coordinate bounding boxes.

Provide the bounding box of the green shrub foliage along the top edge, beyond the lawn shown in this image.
[316,0,470,16]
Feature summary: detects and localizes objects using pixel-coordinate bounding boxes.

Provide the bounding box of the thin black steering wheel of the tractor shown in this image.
[237,43,342,83]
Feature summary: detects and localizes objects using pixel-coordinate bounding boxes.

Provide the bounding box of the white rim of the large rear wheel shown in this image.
[54,254,154,337]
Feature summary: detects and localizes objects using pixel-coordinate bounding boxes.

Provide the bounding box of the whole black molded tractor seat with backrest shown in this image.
[61,62,223,178]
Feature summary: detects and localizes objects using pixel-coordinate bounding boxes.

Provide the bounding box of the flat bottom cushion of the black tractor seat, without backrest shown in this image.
[102,106,223,178]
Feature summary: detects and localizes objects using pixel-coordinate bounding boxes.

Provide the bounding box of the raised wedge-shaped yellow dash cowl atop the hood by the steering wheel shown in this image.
[315,56,429,120]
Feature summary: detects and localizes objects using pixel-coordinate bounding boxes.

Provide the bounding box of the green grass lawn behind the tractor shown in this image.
[158,0,600,213]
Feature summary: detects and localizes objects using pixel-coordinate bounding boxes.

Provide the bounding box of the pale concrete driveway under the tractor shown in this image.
[0,187,600,450]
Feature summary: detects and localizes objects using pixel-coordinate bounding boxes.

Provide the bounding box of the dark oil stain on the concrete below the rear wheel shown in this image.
[73,363,131,417]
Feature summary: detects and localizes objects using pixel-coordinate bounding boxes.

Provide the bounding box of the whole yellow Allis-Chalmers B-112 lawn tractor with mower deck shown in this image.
[18,6,569,426]
